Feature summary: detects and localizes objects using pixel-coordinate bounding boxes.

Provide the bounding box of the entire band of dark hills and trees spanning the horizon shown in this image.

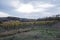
[0,15,60,22]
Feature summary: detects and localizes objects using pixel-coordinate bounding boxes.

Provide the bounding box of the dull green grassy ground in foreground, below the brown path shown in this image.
[0,28,60,40]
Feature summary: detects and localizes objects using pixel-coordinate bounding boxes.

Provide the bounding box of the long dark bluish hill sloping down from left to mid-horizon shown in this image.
[0,17,35,22]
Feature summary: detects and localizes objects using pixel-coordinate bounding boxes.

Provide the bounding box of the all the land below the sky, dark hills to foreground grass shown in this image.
[0,17,60,40]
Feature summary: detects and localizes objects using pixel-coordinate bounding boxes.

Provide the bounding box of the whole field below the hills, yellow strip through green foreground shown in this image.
[0,21,60,40]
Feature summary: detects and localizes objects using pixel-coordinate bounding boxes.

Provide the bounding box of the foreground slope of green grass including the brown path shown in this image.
[0,22,60,40]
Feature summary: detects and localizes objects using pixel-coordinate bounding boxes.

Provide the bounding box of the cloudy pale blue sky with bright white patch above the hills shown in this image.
[0,0,60,19]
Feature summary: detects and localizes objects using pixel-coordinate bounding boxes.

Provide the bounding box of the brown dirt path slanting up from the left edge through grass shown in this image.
[0,28,31,37]
